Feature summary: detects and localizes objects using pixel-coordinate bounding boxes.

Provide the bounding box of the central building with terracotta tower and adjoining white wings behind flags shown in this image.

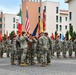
[22,0,68,36]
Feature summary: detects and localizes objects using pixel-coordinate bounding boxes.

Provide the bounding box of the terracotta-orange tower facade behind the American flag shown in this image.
[22,0,41,33]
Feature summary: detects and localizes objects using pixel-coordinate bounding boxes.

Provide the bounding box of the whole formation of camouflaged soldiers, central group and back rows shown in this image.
[0,32,76,67]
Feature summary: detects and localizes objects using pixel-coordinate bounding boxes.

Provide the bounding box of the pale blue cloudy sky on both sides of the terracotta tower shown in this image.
[0,0,68,14]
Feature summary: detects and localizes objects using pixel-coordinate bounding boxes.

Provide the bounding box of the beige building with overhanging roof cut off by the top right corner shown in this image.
[65,0,76,31]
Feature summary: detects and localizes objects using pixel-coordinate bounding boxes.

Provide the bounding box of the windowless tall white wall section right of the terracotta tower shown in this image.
[42,1,60,36]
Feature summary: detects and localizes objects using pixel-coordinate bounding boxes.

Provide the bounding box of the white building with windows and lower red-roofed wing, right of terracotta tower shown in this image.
[41,1,69,37]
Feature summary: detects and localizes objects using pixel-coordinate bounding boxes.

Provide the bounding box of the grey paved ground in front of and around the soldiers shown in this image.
[0,57,76,75]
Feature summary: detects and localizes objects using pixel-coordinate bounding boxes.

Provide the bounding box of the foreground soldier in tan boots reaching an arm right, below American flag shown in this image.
[20,32,32,66]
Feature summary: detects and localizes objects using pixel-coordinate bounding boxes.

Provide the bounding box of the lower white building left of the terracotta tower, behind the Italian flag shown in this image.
[2,14,19,35]
